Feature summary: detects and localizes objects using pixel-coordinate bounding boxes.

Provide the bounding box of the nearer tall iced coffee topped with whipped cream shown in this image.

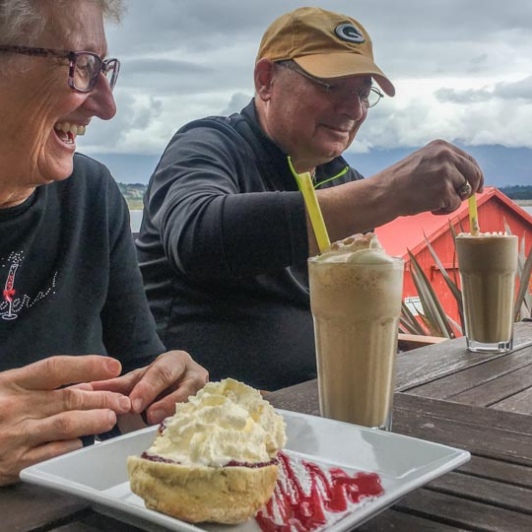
[309,233,403,428]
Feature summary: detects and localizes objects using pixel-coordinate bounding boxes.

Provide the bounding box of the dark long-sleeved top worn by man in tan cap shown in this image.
[137,103,361,390]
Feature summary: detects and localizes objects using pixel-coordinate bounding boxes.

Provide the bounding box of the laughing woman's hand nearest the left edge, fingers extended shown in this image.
[0,355,131,485]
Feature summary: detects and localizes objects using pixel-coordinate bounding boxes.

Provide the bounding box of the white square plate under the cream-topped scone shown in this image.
[20,410,470,532]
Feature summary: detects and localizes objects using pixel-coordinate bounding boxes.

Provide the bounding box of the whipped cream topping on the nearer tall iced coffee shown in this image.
[315,233,393,264]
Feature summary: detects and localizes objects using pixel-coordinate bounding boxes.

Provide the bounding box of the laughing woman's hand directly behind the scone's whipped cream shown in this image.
[91,351,209,424]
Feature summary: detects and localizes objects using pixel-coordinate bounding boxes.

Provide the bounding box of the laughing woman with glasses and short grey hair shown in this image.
[0,0,208,484]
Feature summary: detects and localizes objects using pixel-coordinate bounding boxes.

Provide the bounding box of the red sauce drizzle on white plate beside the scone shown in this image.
[255,452,384,532]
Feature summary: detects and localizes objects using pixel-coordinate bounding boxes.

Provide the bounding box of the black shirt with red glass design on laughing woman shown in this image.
[0,154,164,371]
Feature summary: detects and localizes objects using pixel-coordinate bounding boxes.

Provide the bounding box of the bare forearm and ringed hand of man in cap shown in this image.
[316,140,484,255]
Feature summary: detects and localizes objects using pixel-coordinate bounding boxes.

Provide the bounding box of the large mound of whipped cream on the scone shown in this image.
[147,379,286,467]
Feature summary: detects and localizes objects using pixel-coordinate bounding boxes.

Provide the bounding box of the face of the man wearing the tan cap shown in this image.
[256,62,371,172]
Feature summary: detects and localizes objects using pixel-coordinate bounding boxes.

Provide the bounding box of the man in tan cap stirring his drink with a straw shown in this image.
[137,8,483,389]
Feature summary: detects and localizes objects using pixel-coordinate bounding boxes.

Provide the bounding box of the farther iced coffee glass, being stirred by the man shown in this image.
[456,233,517,353]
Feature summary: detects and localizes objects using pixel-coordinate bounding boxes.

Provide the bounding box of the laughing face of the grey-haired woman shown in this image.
[0,0,116,193]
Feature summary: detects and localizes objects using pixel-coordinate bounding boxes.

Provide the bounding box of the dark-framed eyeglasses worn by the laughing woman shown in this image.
[0,44,120,92]
